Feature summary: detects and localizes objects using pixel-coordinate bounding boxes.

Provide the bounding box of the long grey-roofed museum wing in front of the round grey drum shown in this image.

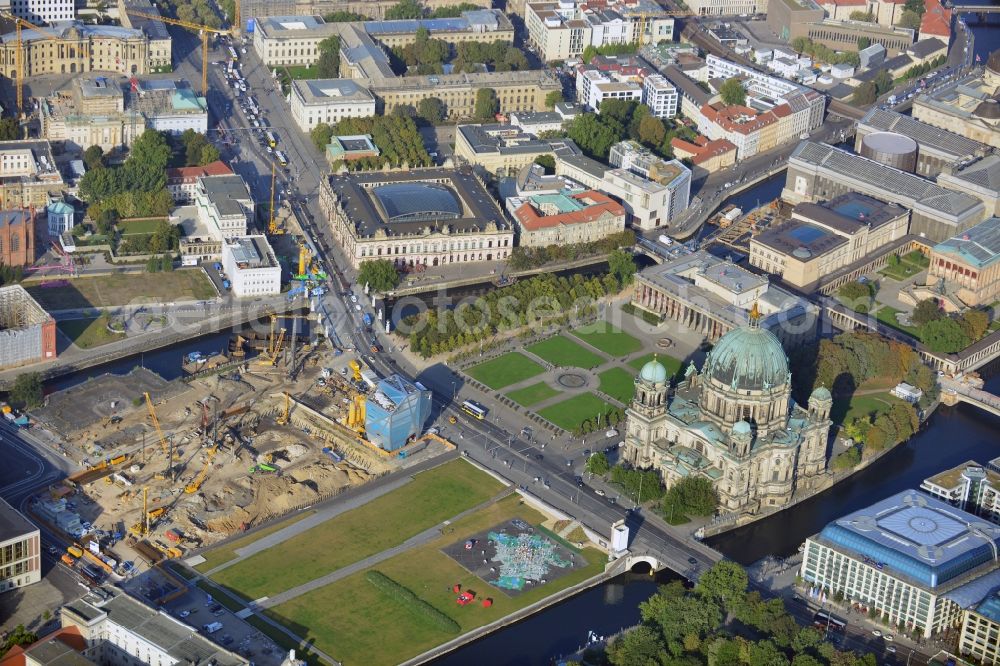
[782,141,986,241]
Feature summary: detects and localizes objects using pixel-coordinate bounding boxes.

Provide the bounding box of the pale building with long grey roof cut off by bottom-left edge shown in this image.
[59,587,250,666]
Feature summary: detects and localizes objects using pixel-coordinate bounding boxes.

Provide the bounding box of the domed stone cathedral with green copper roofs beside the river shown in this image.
[624,316,833,514]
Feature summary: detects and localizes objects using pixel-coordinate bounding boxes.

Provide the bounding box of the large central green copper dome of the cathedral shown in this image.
[702,326,788,391]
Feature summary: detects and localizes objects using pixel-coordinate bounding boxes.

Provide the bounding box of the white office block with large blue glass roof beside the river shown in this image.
[799,490,1000,638]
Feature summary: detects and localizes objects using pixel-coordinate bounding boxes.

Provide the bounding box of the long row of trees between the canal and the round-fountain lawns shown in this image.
[401,274,621,358]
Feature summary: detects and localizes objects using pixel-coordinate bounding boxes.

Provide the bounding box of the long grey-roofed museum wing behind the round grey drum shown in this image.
[855,106,993,178]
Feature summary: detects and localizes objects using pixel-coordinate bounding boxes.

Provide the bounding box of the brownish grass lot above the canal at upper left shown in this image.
[24,268,217,310]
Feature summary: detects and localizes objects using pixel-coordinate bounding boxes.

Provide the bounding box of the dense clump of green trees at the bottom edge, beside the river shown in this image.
[607,560,876,666]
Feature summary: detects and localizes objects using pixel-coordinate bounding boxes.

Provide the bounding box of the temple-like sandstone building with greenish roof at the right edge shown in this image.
[927,217,1000,307]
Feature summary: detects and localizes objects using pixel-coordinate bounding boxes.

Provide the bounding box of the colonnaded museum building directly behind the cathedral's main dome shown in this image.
[632,250,819,348]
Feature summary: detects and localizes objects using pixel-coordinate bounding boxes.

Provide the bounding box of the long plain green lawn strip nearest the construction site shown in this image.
[212,459,502,599]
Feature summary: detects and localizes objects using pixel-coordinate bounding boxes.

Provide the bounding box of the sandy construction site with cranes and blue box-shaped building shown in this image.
[30,304,454,582]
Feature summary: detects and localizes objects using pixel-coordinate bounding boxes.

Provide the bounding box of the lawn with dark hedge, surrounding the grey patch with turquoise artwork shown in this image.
[268,496,607,666]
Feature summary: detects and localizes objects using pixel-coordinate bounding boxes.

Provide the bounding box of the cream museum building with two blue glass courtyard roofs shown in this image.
[750,192,910,290]
